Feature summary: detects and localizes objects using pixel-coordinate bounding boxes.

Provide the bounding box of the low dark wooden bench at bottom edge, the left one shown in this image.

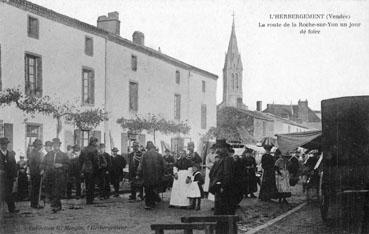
[151,222,217,234]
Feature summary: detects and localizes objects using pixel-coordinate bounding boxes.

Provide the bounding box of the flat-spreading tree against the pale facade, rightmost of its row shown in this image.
[117,114,191,143]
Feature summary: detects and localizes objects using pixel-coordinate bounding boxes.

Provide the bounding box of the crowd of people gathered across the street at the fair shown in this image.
[0,137,313,215]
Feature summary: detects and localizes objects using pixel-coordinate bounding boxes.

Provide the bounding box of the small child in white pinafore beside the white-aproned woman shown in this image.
[188,164,204,210]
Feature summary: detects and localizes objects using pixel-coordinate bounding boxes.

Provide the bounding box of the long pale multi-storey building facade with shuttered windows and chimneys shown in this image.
[0,0,217,156]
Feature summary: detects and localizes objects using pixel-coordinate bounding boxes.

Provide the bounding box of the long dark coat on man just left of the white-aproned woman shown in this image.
[138,149,164,186]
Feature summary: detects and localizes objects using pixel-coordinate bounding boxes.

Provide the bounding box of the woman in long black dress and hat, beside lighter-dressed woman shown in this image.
[259,145,277,201]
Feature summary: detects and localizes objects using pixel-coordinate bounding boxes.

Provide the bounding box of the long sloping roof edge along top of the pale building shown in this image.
[2,0,218,80]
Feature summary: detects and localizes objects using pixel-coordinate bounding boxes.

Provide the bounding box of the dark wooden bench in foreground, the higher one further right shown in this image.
[181,215,240,234]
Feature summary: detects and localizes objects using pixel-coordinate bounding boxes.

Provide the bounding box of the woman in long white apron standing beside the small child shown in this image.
[169,151,192,208]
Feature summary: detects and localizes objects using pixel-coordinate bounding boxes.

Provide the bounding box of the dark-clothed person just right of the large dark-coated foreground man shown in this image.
[242,148,257,198]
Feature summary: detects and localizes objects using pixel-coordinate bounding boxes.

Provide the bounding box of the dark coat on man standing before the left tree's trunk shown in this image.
[41,150,70,195]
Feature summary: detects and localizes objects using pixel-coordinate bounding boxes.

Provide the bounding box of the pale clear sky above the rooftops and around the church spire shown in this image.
[31,0,369,110]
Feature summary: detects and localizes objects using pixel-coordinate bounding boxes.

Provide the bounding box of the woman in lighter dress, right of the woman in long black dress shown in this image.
[275,150,291,203]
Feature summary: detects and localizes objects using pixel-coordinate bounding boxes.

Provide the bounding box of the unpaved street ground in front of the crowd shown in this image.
[0,186,304,234]
